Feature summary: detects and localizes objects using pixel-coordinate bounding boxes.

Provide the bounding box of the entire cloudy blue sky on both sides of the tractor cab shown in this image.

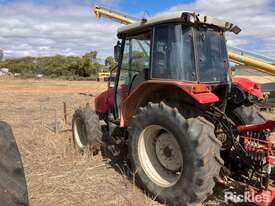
[0,0,275,58]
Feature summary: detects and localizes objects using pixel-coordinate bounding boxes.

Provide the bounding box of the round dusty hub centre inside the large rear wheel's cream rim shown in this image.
[156,133,181,171]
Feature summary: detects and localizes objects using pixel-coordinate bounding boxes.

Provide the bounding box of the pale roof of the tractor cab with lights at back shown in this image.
[118,11,241,37]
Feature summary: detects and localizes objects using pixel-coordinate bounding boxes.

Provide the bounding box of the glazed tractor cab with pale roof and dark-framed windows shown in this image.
[109,12,243,120]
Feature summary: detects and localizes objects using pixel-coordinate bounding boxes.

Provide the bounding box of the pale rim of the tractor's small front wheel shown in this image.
[73,118,87,149]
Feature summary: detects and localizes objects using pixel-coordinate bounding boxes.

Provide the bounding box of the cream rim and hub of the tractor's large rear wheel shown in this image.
[138,125,183,187]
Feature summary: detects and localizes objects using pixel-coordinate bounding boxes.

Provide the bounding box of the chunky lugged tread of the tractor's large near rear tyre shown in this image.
[129,102,223,205]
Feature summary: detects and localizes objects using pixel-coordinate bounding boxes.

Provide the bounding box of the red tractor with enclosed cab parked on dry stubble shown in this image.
[73,12,275,205]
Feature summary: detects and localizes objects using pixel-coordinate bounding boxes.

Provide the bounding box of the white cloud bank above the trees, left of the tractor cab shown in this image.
[0,1,119,57]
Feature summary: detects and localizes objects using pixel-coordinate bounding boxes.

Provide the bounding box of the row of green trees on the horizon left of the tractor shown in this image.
[0,51,115,80]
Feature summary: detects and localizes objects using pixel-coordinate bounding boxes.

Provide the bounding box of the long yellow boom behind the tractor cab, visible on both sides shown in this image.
[93,5,275,76]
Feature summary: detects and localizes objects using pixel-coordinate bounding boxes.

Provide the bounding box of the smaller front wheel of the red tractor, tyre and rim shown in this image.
[72,105,102,153]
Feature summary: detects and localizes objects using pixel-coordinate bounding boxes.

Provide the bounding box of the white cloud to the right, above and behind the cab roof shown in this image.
[169,0,275,58]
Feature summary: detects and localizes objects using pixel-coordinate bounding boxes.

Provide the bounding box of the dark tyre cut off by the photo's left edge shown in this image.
[0,122,29,206]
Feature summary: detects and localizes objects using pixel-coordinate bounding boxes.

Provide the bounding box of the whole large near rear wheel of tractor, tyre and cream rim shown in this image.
[128,102,223,206]
